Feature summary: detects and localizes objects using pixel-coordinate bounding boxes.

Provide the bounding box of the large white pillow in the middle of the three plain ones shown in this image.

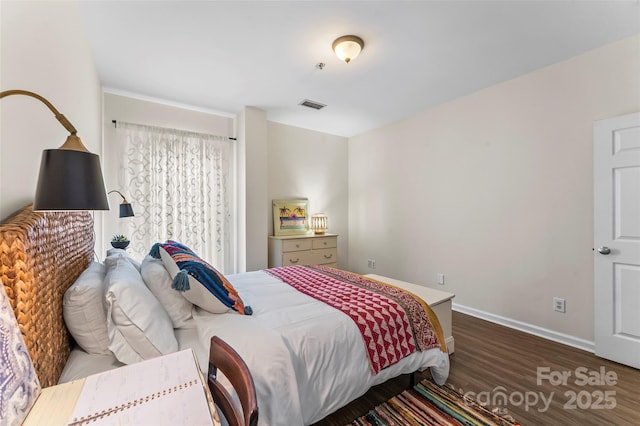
[105,256,178,364]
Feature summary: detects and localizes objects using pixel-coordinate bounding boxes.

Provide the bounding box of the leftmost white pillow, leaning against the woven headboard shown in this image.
[62,262,111,354]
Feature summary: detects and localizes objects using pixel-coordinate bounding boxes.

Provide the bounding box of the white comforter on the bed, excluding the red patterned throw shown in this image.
[193,271,449,425]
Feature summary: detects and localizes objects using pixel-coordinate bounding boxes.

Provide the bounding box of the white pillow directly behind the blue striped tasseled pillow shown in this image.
[140,255,193,328]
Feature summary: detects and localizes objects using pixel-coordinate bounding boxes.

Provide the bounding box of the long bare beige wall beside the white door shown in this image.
[349,36,640,341]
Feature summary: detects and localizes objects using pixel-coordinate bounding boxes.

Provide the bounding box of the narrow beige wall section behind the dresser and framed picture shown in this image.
[268,122,349,268]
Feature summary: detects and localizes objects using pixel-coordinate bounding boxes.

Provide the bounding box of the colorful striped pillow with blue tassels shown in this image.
[154,240,253,315]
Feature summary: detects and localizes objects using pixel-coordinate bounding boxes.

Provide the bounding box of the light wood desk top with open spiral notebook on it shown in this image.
[27,349,217,426]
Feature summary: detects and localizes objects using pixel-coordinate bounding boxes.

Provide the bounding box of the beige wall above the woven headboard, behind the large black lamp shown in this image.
[0,1,102,236]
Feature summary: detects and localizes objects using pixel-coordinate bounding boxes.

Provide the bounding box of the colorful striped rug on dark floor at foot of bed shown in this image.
[351,380,520,426]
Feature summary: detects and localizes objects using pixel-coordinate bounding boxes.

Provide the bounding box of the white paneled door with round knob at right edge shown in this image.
[593,113,640,368]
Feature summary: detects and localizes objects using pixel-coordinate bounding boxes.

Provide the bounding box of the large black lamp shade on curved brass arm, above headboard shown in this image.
[33,149,109,211]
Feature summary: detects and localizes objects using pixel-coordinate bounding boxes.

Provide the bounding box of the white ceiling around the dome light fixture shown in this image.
[79,0,640,136]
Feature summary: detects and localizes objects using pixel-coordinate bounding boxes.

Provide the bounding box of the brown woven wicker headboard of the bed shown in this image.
[0,205,94,387]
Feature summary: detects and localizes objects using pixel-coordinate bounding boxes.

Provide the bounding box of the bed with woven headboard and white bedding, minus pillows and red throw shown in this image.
[0,206,449,425]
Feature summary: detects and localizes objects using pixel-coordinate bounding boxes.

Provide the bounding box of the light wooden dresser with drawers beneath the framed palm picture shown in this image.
[269,234,338,268]
